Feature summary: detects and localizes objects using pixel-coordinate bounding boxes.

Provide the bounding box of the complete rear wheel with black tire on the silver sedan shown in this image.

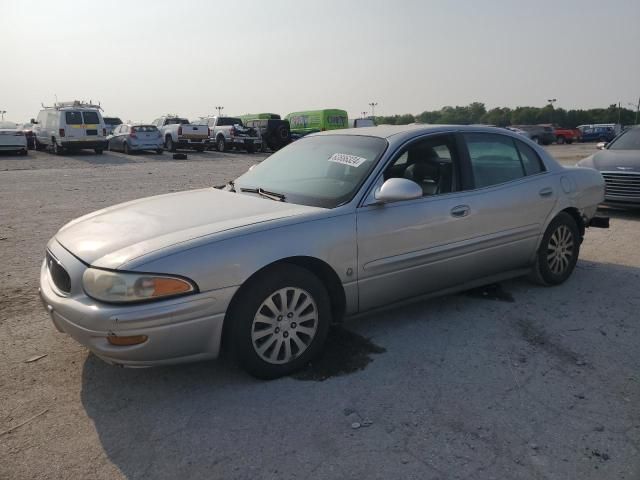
[532,212,581,286]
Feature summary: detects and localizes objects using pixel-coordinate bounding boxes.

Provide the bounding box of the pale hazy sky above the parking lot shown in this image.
[0,0,640,122]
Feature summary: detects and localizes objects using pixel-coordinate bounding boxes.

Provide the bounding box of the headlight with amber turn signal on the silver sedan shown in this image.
[82,268,197,303]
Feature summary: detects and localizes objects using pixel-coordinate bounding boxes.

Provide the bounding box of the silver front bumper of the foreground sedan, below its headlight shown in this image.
[40,240,237,367]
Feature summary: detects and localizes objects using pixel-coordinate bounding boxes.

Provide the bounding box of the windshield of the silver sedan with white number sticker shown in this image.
[235,135,387,208]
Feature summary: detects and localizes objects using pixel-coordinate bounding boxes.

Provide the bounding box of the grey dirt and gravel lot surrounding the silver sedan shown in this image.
[0,145,640,480]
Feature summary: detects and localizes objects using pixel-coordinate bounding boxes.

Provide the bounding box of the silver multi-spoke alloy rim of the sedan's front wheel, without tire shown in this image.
[251,287,318,364]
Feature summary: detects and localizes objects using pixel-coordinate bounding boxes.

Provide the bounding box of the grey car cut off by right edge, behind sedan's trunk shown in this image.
[578,127,640,207]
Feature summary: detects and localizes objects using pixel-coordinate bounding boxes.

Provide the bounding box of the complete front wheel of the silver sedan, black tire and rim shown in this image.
[226,264,331,379]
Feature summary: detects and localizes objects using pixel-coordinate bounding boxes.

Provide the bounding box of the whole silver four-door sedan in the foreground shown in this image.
[40,125,606,378]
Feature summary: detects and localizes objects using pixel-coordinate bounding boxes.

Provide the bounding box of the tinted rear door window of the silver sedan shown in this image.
[464,133,525,188]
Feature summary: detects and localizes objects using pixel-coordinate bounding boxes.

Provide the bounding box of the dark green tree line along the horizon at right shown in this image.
[375,102,637,128]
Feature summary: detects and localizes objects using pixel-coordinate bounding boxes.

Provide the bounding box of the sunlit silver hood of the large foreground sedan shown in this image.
[55,188,323,268]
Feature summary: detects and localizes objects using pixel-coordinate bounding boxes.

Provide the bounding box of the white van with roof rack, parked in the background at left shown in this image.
[32,100,107,155]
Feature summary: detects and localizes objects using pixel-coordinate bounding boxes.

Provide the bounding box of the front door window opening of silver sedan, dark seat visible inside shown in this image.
[384,135,458,196]
